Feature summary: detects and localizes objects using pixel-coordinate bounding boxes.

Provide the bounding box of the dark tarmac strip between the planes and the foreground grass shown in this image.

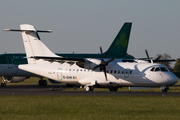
[0,85,180,96]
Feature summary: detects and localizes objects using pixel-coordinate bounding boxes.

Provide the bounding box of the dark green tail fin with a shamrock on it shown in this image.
[104,22,132,57]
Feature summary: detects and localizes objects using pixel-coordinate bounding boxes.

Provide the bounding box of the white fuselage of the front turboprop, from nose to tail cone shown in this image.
[20,61,178,87]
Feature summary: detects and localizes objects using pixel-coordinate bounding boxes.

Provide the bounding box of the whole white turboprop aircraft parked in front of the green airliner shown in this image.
[3,24,178,92]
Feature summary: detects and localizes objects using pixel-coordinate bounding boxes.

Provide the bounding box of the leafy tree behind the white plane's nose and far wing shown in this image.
[157,53,173,71]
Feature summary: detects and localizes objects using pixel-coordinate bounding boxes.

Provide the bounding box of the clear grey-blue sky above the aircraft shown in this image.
[0,0,180,66]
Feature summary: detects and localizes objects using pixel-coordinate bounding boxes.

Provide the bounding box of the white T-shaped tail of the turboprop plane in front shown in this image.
[4,24,59,64]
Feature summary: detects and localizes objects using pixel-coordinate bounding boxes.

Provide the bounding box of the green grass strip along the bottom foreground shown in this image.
[0,95,180,120]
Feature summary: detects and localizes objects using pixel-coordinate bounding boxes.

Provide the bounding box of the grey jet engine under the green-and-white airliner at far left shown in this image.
[4,76,29,83]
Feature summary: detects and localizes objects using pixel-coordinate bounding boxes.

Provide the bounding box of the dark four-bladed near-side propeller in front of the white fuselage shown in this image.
[93,47,115,81]
